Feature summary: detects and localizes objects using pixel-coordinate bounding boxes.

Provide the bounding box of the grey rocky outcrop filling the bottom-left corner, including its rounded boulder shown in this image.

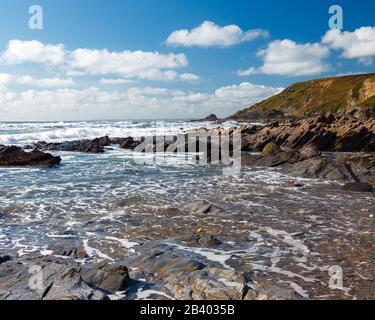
[0,252,129,300]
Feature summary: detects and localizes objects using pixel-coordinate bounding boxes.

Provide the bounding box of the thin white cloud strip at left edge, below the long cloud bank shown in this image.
[0,73,76,88]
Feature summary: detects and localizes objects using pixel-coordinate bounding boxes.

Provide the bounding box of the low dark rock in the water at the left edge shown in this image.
[0,146,61,167]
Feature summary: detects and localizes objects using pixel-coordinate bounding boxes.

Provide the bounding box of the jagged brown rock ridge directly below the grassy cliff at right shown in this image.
[242,114,375,152]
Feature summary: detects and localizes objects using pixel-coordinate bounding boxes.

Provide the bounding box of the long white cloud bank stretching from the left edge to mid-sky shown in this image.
[0,40,192,81]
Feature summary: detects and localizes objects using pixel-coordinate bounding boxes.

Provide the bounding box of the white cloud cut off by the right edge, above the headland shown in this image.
[322,27,375,59]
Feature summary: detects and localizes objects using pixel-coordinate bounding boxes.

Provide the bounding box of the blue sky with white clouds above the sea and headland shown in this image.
[0,0,375,121]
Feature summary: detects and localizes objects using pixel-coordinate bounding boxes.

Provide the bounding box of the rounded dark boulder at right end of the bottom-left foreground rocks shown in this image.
[79,262,130,293]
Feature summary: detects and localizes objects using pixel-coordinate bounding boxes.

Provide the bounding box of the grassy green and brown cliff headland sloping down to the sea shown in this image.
[231,74,375,119]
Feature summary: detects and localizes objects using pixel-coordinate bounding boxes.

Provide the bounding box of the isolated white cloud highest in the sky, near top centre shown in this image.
[167,21,268,47]
